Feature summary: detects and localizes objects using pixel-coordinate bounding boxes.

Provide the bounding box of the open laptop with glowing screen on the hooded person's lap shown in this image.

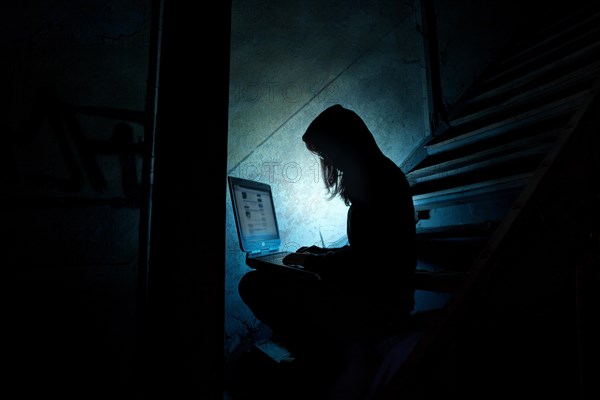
[227,176,321,280]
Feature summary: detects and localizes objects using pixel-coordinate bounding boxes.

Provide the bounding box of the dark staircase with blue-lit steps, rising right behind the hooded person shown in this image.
[381,2,600,398]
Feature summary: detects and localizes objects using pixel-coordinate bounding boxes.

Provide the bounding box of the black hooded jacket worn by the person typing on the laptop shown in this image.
[302,105,416,310]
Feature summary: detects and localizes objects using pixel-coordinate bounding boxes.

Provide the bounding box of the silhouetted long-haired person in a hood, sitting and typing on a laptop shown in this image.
[238,105,416,368]
